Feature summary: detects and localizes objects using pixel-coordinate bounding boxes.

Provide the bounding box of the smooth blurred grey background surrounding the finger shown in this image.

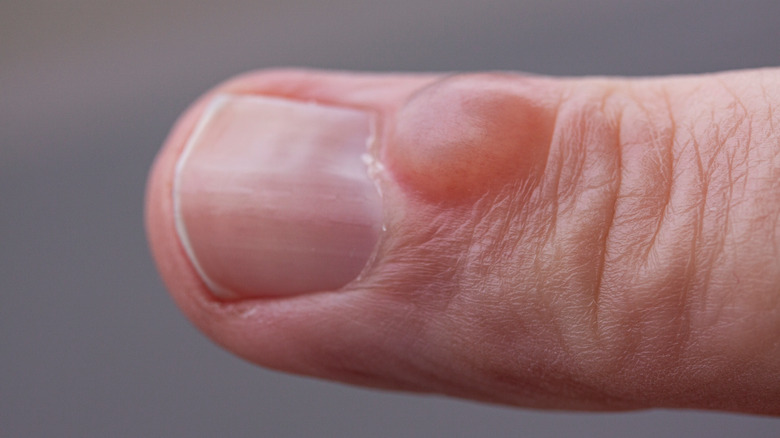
[0,0,780,437]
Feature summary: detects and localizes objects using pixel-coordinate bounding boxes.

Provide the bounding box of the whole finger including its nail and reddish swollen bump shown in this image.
[147,71,780,412]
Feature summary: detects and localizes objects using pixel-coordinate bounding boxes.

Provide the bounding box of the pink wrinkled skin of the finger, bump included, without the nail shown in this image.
[147,69,780,415]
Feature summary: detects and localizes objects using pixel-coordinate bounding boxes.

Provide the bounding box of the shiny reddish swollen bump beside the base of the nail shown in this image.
[384,74,555,201]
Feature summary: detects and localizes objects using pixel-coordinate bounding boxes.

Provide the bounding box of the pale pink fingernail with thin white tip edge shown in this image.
[173,95,382,298]
